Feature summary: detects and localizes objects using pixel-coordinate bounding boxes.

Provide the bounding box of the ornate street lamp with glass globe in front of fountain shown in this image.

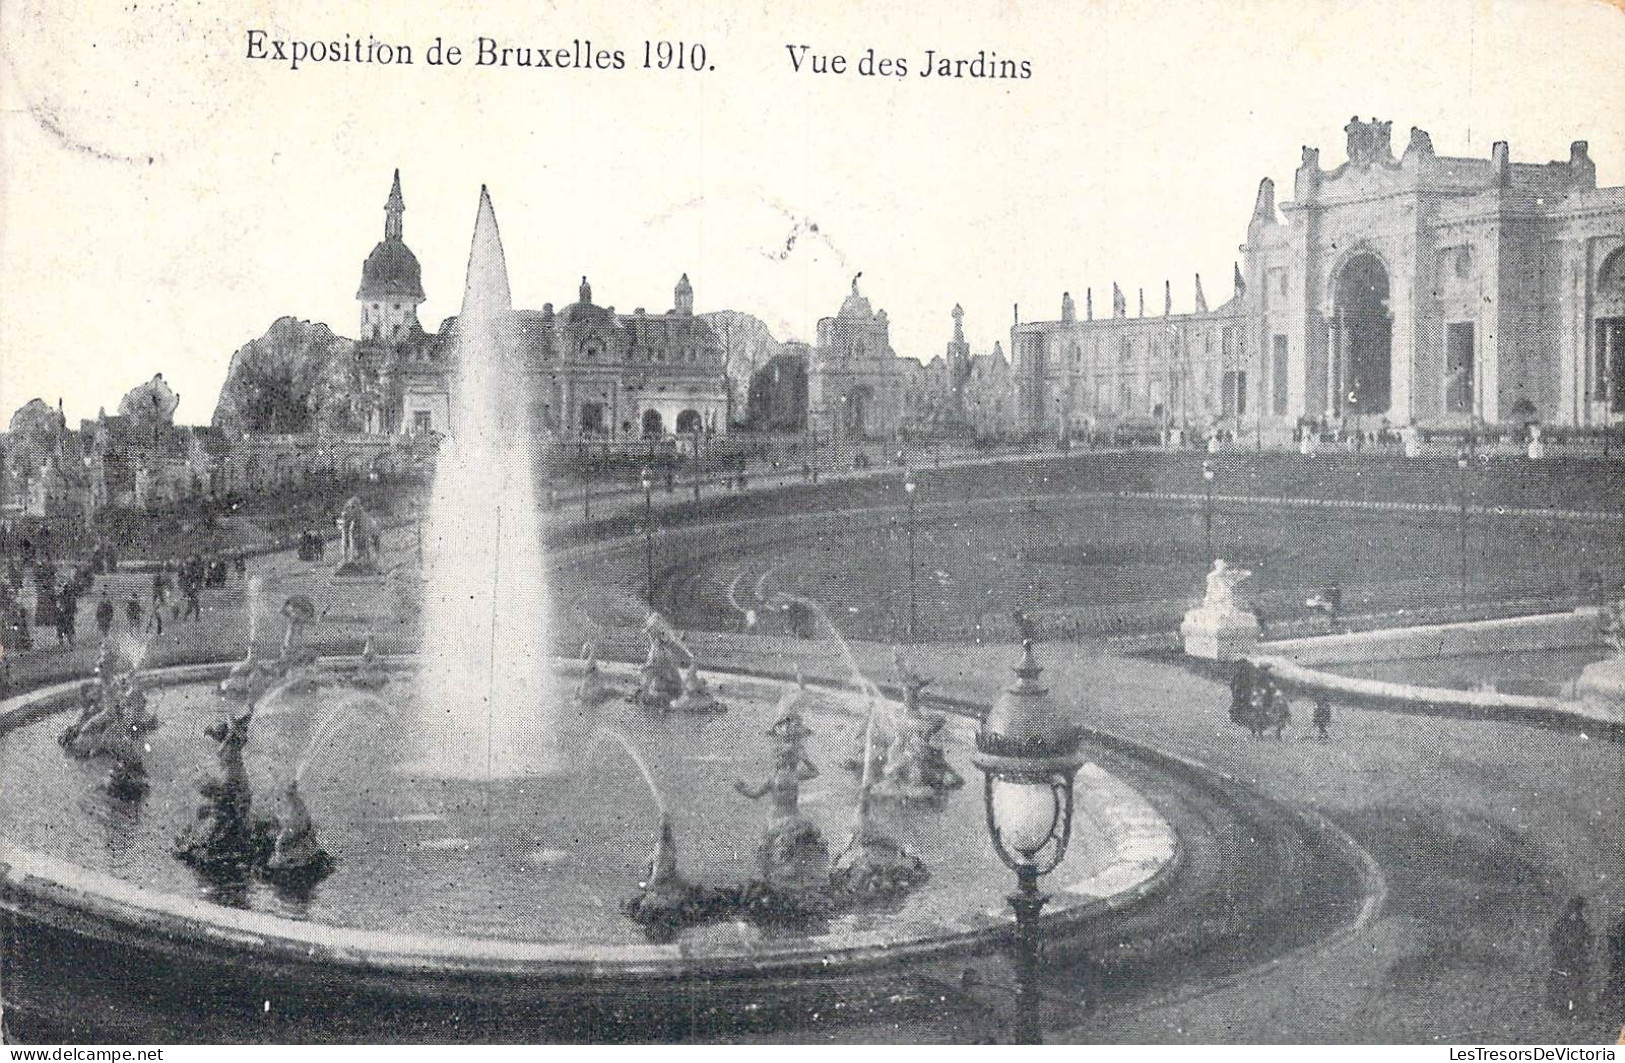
[970,639,1084,1045]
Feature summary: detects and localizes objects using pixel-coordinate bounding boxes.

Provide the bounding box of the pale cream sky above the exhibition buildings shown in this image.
[0,0,1625,423]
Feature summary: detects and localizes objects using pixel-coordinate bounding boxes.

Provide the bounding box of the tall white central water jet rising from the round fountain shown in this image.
[411,189,557,779]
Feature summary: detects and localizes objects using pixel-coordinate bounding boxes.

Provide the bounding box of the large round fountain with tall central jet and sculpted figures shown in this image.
[0,181,1163,1040]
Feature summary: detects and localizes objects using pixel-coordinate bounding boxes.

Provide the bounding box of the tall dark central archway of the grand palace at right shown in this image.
[1329,254,1394,416]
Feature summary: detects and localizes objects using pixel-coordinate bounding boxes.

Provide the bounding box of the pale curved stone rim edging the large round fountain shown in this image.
[0,655,1183,980]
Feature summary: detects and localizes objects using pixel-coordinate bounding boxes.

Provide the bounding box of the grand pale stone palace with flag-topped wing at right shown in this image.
[1011,119,1625,439]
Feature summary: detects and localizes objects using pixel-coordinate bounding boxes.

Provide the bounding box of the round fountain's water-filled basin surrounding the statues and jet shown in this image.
[0,658,1178,1033]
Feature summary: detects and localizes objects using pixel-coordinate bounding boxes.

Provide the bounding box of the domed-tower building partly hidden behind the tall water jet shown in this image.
[356,172,728,439]
